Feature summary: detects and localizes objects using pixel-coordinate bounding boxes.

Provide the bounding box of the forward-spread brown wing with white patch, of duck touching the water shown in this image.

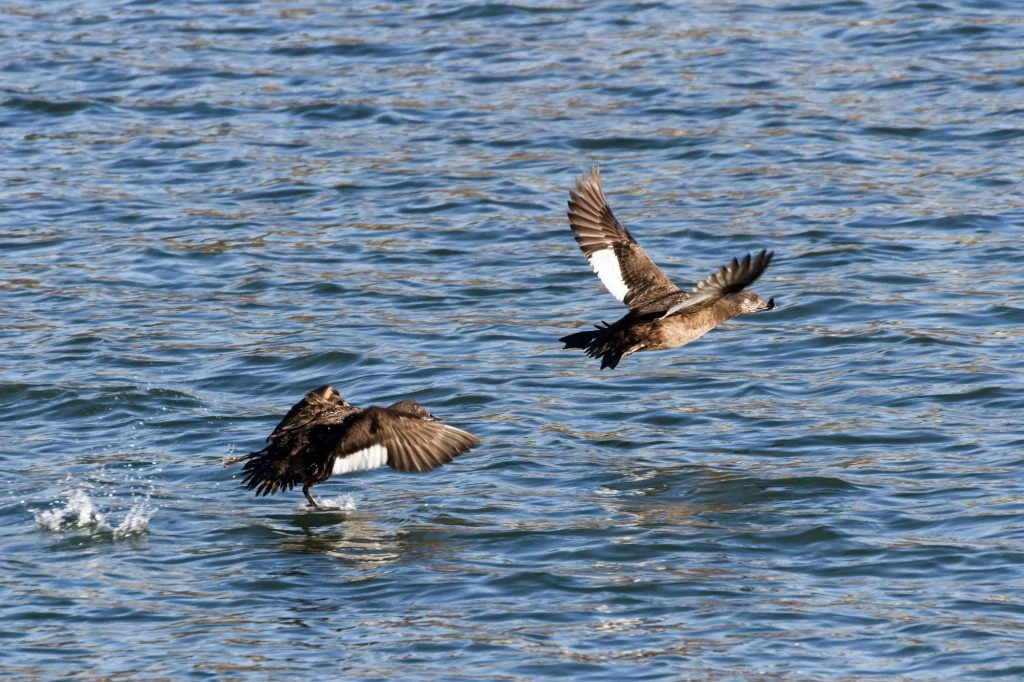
[334,407,480,474]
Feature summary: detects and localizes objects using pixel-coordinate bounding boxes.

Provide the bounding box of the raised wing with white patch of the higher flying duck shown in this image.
[568,166,679,309]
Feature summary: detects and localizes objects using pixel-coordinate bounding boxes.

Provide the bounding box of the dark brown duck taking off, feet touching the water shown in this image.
[224,385,480,509]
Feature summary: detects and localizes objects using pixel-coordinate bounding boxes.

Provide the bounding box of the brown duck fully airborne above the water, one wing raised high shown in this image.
[559,166,775,370]
